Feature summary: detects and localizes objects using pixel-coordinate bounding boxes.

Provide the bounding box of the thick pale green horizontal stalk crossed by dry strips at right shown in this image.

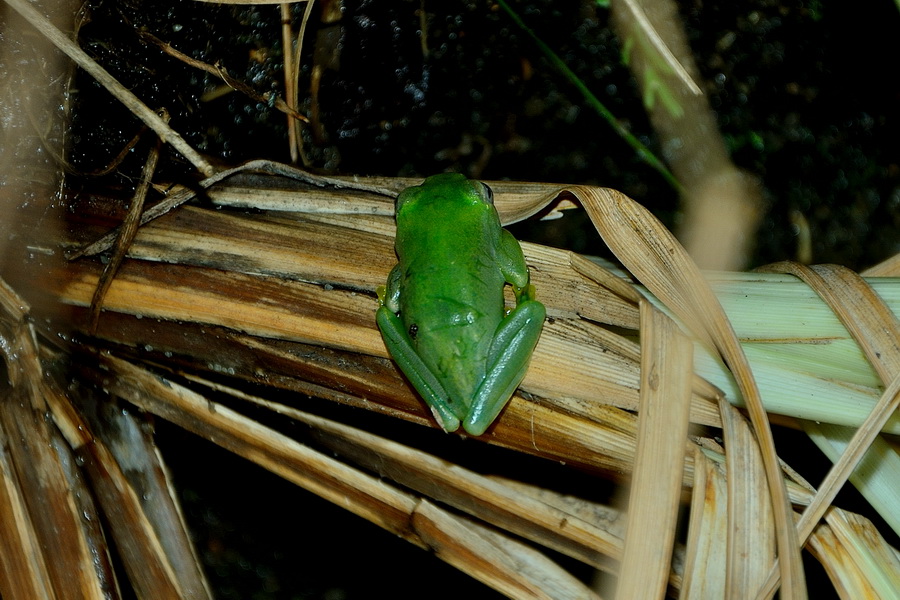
[684,273,900,435]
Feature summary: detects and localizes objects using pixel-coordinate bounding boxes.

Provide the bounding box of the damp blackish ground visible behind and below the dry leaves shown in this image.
[71,0,900,600]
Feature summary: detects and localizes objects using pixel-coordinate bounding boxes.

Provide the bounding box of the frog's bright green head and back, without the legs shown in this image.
[397,178,504,405]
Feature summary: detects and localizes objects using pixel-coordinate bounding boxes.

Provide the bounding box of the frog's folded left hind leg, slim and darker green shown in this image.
[375,306,465,433]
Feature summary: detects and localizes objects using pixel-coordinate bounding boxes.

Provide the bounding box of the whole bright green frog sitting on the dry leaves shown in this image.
[376,173,546,435]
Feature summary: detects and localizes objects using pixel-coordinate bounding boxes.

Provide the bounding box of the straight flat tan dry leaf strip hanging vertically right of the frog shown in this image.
[616,301,693,598]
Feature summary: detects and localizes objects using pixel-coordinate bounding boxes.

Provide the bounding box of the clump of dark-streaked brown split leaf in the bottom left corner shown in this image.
[0,284,210,599]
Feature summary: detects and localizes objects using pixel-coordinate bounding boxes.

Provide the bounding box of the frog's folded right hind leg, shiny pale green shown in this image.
[463,300,547,435]
